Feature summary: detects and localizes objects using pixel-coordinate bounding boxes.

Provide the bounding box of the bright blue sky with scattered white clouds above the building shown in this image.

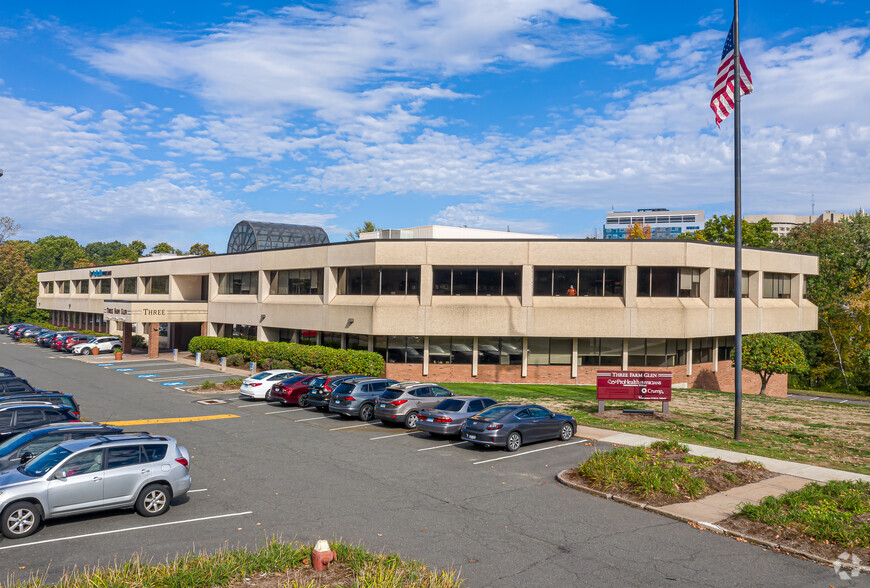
[0,0,870,251]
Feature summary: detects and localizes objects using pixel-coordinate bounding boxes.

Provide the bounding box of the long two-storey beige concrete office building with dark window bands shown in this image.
[38,239,818,394]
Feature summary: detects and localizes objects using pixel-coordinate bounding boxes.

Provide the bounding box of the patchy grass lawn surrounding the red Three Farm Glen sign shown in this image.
[443,382,870,474]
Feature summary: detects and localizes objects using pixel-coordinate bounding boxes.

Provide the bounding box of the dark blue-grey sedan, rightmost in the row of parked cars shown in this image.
[460,404,577,451]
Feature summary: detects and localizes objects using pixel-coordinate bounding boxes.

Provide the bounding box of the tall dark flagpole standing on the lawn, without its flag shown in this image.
[732,0,743,441]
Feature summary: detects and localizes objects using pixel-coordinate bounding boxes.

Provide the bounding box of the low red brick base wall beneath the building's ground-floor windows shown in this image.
[387,361,788,398]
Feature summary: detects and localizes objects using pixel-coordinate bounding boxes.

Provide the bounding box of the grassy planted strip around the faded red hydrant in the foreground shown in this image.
[12,539,462,588]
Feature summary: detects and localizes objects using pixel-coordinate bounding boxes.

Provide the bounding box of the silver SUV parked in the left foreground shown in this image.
[0,433,190,539]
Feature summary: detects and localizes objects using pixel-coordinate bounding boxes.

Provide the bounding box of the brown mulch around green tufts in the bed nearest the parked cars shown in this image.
[567,452,778,506]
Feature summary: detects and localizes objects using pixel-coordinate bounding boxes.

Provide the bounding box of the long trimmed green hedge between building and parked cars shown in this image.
[188,337,385,376]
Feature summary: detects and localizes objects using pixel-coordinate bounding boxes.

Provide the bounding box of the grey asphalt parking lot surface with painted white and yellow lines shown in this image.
[0,345,835,586]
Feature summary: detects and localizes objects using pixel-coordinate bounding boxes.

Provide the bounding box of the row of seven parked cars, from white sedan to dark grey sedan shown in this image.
[240,370,577,451]
